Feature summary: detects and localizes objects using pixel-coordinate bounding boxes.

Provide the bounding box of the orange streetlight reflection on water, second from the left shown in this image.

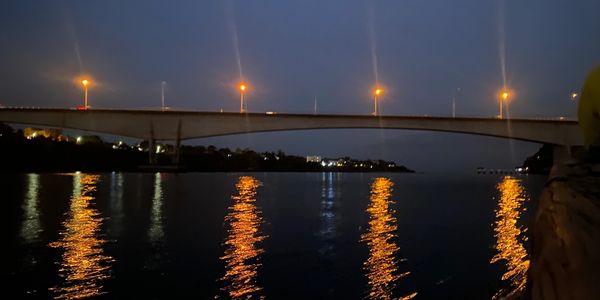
[221,176,266,299]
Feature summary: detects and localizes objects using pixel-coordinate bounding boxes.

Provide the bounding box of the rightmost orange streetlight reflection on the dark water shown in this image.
[490,176,529,299]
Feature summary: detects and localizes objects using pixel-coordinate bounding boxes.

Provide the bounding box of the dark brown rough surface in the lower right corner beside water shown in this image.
[528,164,600,299]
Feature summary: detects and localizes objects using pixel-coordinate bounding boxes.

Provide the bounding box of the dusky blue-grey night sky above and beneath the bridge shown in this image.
[0,0,600,171]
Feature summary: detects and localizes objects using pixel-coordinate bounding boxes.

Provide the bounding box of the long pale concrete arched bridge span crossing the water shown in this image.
[0,108,583,146]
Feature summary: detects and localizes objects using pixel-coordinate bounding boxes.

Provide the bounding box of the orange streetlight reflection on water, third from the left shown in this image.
[361,177,417,299]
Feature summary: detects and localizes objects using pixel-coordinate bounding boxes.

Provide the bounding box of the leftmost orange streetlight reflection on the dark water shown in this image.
[50,173,113,299]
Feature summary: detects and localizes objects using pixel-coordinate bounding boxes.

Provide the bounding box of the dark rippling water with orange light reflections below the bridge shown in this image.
[0,173,544,299]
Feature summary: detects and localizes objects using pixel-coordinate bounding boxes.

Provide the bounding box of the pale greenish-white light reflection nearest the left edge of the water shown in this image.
[20,174,42,244]
